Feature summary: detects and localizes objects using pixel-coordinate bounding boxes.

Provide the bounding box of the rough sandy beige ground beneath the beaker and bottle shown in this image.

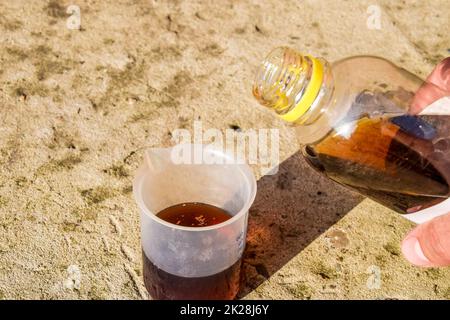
[0,0,450,299]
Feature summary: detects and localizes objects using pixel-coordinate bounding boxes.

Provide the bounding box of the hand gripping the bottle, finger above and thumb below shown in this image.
[402,57,450,267]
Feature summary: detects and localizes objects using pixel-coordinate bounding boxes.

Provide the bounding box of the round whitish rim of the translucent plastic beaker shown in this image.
[133,144,257,232]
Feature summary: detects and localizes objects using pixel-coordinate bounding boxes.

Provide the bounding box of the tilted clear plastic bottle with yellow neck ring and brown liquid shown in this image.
[253,47,450,222]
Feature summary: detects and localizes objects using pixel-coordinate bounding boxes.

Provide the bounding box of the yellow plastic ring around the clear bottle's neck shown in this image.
[280,56,324,122]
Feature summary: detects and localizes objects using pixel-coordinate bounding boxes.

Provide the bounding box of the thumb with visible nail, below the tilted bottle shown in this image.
[402,213,450,267]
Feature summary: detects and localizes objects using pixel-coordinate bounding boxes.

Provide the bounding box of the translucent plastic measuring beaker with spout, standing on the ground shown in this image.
[133,144,256,299]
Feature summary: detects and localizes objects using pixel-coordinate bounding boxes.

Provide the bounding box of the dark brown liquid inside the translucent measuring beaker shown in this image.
[143,202,241,300]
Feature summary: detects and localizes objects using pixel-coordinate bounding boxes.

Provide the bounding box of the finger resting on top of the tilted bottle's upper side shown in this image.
[410,57,450,114]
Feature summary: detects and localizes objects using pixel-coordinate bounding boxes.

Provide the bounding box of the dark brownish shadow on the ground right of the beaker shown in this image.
[238,152,364,297]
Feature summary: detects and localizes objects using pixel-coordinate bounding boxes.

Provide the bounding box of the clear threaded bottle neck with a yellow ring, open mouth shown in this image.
[253,47,334,125]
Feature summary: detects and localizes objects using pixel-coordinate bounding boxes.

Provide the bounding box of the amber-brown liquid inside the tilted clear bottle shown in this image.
[304,116,450,213]
